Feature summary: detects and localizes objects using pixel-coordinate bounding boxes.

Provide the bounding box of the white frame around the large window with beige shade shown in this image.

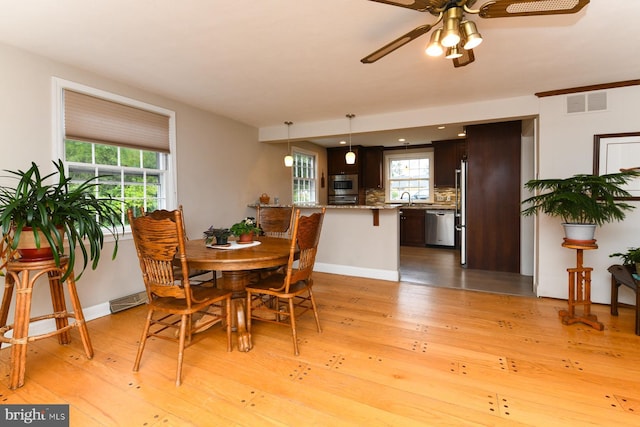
[51,77,178,238]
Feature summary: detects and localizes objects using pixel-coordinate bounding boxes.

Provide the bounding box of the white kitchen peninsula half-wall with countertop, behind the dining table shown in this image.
[250,204,402,281]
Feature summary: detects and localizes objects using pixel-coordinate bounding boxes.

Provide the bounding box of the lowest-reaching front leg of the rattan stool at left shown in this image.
[9,270,33,390]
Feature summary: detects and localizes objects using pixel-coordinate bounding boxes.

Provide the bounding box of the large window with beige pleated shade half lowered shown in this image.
[54,79,175,229]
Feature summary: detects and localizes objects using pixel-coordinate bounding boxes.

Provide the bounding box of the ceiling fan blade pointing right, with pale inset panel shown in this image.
[480,0,589,18]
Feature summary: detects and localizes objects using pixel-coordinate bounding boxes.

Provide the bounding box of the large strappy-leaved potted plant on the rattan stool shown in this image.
[0,160,122,280]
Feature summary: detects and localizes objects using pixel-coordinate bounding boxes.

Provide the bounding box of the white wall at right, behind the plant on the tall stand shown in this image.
[538,86,640,303]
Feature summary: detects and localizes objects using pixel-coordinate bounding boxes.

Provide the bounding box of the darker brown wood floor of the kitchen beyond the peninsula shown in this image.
[400,246,535,296]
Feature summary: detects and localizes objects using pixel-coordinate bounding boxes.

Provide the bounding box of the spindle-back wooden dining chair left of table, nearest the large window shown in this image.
[127,208,231,385]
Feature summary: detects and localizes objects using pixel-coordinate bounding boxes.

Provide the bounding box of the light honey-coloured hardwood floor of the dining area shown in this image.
[0,273,640,426]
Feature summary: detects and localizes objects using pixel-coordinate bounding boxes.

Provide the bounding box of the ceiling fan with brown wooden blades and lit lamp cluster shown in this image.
[360,0,589,67]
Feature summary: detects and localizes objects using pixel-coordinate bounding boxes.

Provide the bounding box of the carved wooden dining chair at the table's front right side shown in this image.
[246,208,325,356]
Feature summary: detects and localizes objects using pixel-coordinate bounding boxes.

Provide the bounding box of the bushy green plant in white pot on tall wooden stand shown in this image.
[522,171,640,241]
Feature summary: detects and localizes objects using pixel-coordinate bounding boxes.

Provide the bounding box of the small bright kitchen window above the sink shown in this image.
[385,151,433,203]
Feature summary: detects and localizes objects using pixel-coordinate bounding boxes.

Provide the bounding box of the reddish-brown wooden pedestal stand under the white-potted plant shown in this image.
[558,238,604,331]
